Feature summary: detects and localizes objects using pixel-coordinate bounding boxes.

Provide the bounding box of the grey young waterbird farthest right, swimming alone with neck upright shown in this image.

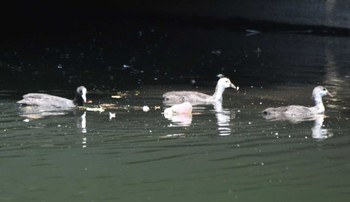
[263,86,333,122]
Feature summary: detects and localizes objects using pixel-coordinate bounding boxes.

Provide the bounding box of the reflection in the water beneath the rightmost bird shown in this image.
[263,114,333,140]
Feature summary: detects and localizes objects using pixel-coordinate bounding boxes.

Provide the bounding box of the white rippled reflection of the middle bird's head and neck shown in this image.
[214,102,231,136]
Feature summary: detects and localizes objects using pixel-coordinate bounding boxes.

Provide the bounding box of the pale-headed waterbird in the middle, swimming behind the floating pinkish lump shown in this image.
[163,77,239,105]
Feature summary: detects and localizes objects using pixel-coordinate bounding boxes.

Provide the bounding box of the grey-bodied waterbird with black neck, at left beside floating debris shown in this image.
[17,86,87,111]
